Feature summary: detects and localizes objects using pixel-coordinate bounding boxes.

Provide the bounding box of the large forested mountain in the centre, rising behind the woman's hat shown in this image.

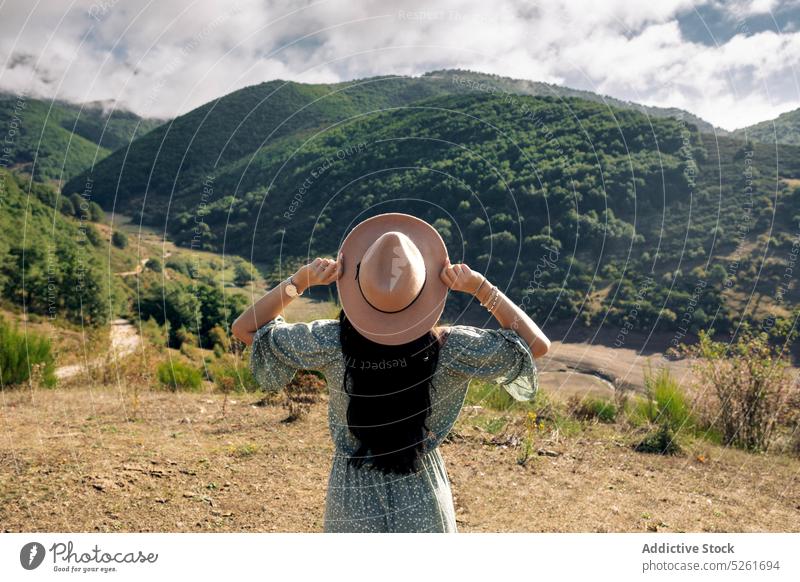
[64,73,800,340]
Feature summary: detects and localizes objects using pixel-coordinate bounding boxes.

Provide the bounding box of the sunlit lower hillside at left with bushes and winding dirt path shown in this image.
[0,170,262,356]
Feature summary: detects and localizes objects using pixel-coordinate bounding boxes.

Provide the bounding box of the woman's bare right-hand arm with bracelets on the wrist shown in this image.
[441,260,550,358]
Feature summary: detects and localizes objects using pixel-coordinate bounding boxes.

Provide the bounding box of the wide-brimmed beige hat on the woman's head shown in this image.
[336,213,448,345]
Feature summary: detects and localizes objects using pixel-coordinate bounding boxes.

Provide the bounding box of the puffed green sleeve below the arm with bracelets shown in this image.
[444,325,539,400]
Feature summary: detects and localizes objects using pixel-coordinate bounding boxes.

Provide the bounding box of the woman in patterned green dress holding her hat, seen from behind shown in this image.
[232,213,550,532]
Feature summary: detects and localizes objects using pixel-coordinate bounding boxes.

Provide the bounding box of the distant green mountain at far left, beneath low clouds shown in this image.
[0,94,162,181]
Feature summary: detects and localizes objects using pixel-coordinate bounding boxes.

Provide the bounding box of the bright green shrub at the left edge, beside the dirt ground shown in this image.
[0,317,56,389]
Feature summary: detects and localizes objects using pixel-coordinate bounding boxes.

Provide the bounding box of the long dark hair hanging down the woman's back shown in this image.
[339,310,442,473]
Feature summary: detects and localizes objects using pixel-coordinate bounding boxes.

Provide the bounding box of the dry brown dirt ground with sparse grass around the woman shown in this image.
[0,387,800,532]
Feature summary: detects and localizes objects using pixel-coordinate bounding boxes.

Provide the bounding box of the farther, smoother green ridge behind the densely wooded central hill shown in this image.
[65,71,711,211]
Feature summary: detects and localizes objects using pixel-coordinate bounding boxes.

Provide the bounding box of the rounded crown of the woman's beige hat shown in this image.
[358,231,425,313]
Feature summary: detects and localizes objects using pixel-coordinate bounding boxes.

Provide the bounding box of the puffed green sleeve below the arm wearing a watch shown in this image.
[250,315,341,392]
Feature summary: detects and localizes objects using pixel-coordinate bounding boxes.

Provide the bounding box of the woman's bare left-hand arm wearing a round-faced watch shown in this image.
[231,255,343,346]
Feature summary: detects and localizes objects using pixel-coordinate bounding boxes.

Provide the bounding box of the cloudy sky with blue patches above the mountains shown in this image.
[0,0,800,130]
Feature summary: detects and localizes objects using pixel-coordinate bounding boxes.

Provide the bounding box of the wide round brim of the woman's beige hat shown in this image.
[336,212,448,345]
